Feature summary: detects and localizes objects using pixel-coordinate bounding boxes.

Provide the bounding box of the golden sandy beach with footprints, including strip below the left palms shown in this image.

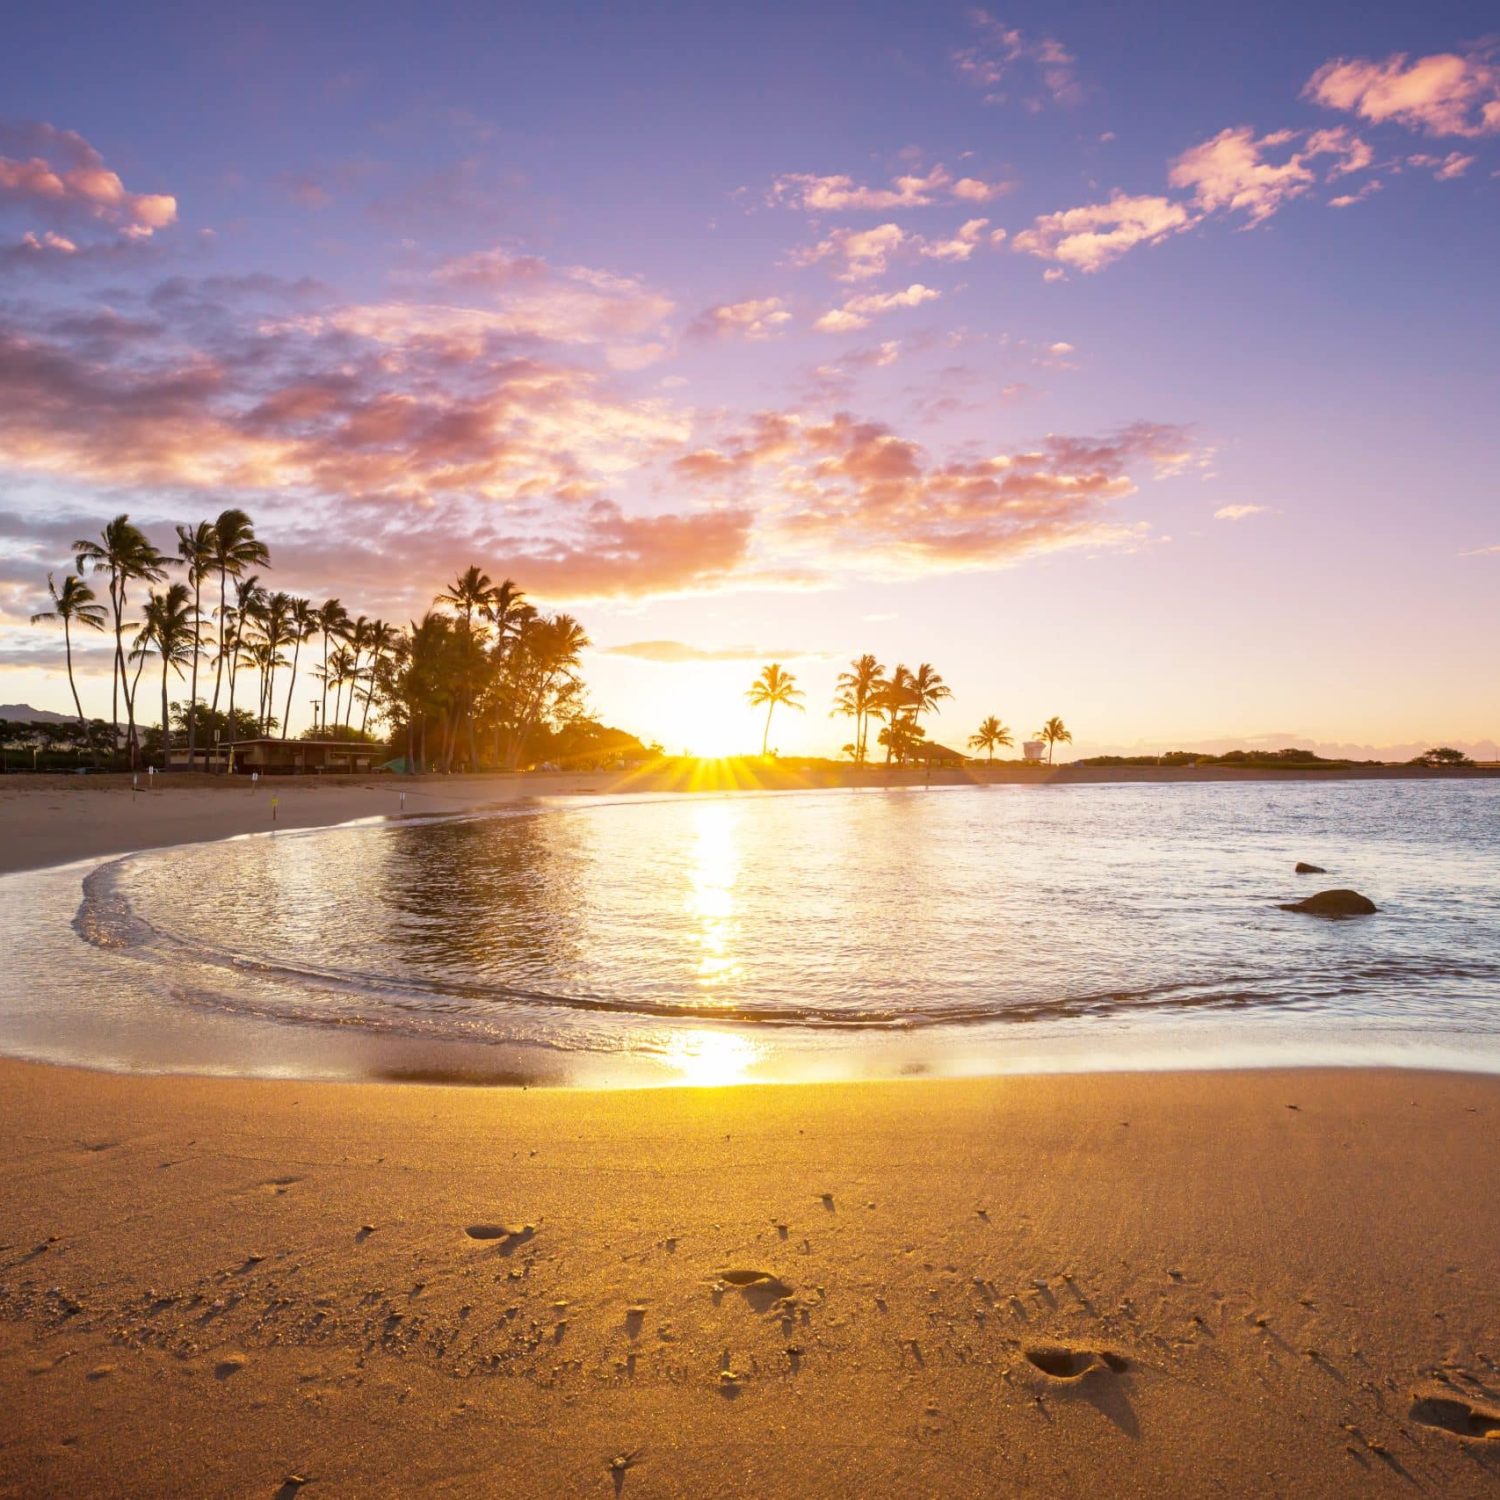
[0,777,1500,1497]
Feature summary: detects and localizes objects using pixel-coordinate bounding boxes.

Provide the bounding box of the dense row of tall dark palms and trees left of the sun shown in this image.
[32,509,588,770]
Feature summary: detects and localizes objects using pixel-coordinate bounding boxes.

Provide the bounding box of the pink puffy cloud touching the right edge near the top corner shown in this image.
[1302,47,1500,138]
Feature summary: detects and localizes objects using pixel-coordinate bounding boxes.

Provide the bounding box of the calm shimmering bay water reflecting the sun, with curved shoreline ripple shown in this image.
[0,782,1500,1085]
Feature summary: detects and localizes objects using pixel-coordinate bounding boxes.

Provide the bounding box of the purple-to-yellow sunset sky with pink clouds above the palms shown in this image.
[0,0,1500,755]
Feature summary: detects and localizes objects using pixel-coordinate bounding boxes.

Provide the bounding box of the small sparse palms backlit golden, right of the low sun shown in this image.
[746,654,1073,765]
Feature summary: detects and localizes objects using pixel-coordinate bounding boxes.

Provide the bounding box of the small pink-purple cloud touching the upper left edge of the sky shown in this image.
[0,122,177,240]
